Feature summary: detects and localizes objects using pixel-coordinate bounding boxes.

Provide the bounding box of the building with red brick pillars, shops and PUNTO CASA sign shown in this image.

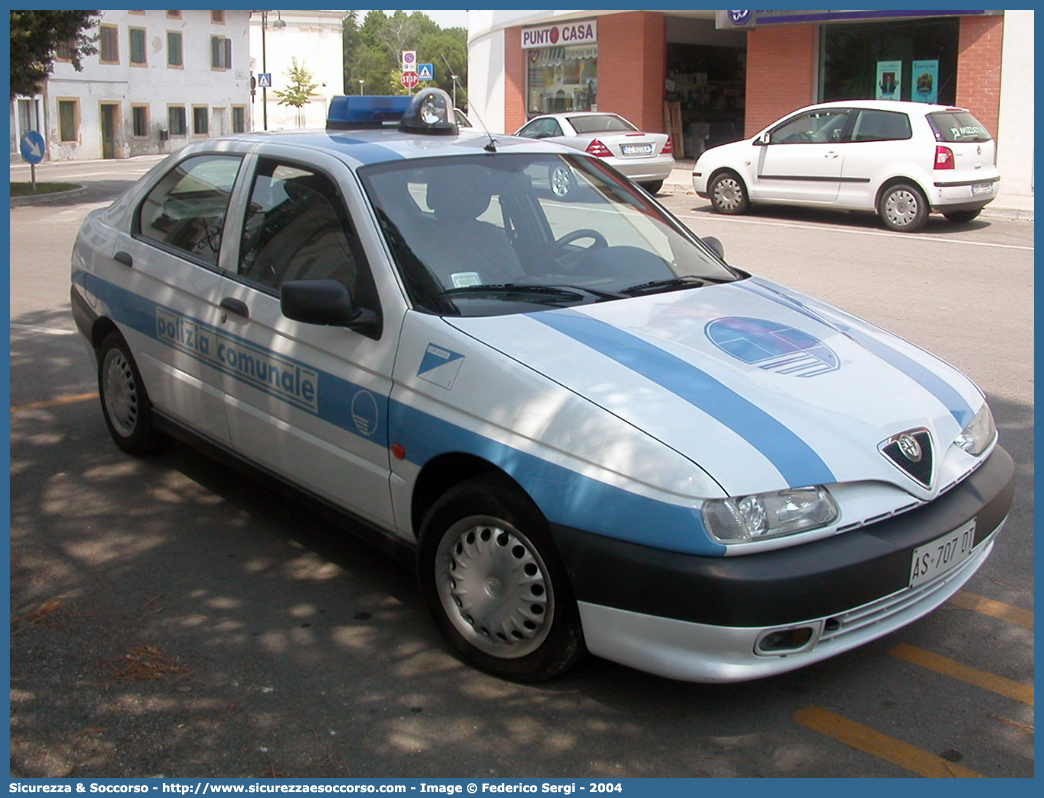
[468,9,1034,210]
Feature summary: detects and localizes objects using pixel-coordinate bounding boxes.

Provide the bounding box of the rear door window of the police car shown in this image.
[137,156,242,265]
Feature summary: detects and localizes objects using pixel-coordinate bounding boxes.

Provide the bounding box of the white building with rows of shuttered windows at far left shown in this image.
[10,9,253,161]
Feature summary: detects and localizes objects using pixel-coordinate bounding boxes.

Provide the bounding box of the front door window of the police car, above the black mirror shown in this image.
[239,159,376,308]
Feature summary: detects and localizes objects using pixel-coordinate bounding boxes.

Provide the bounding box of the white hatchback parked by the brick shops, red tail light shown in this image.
[692,100,1000,232]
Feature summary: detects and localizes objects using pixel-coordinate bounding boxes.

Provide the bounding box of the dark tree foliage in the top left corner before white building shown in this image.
[10,10,101,99]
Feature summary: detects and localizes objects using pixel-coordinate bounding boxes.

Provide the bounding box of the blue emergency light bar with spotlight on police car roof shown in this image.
[327,89,458,136]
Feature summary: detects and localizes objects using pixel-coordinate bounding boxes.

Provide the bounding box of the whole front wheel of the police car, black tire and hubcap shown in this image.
[418,476,587,682]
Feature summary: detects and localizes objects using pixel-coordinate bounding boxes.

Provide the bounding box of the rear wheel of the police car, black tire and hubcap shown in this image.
[98,331,167,454]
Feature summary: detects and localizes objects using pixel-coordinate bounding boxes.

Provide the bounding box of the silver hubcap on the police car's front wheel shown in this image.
[435,516,554,659]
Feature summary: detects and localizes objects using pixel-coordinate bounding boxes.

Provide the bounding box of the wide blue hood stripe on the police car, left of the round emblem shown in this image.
[529,310,835,488]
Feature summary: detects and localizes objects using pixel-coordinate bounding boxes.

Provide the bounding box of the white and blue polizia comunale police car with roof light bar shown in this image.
[72,90,1014,682]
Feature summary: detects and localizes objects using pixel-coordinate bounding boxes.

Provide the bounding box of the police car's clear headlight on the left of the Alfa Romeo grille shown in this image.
[704,487,837,543]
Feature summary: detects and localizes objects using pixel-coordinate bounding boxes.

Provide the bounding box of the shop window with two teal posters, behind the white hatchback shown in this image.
[820,19,960,104]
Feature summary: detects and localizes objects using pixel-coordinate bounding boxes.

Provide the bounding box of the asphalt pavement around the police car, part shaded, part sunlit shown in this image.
[10,161,1034,778]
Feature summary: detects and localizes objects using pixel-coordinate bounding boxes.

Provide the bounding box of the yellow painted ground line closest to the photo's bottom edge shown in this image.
[793,706,986,778]
